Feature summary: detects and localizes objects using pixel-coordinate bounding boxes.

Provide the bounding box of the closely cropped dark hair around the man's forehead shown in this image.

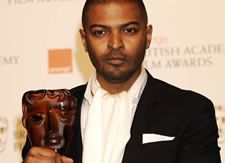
[82,0,148,29]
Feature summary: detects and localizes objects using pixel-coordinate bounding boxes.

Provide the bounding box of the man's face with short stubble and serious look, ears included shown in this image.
[80,2,152,83]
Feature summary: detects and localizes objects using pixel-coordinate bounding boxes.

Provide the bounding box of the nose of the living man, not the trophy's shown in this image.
[108,31,124,50]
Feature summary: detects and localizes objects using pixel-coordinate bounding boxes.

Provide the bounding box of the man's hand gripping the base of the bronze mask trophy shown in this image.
[24,147,73,163]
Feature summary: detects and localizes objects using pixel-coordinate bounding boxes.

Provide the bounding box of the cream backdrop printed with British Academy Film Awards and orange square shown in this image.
[0,0,225,162]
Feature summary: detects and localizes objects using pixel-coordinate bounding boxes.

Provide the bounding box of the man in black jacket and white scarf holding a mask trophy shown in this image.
[23,0,221,163]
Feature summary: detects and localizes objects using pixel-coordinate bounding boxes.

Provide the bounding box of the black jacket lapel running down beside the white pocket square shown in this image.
[122,73,162,163]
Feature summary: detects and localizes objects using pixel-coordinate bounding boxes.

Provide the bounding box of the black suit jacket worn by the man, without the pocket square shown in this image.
[23,74,221,163]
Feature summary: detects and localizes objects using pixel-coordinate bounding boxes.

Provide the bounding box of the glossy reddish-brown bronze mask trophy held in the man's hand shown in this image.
[22,89,77,154]
